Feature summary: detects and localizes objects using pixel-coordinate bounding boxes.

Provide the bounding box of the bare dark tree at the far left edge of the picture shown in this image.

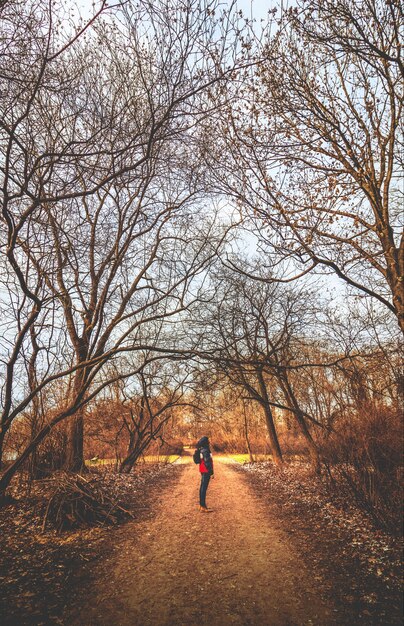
[0,0,113,464]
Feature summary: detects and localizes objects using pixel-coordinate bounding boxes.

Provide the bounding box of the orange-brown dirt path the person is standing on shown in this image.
[73,458,334,626]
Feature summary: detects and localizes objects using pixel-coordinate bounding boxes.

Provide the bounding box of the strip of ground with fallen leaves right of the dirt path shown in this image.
[240,462,403,626]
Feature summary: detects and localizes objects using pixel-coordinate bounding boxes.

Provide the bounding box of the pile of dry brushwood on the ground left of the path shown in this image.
[42,474,130,532]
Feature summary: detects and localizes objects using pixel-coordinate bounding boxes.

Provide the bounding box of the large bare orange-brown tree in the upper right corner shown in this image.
[214,0,404,330]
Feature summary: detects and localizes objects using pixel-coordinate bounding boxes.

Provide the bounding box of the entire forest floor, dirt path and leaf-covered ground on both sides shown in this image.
[0,456,402,626]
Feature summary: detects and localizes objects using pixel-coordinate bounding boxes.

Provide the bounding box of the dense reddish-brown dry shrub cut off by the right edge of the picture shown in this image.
[322,405,403,533]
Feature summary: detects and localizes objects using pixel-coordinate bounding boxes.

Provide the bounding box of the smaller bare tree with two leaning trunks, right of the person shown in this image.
[198,261,326,467]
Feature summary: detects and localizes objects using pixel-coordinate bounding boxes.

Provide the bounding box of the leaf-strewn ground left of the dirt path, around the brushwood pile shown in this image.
[0,464,182,626]
